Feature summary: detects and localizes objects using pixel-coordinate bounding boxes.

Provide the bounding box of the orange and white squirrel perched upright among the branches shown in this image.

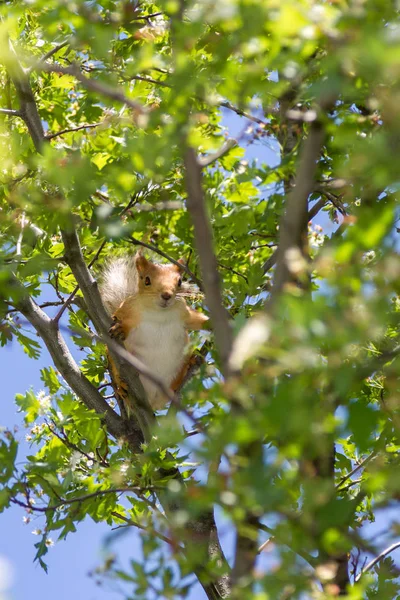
[100,253,209,410]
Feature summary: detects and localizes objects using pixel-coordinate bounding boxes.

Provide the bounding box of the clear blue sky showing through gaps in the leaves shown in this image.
[0,110,400,600]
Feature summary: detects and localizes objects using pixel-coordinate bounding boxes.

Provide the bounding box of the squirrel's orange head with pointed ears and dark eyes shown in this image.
[136,254,185,308]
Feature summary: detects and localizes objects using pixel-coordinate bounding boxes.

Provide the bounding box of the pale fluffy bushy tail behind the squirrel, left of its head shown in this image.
[100,256,138,314]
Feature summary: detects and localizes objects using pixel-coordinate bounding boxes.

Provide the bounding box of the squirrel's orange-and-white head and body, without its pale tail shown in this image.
[103,254,208,409]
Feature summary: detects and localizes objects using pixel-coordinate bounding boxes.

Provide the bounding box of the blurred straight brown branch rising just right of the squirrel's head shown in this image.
[184,148,232,377]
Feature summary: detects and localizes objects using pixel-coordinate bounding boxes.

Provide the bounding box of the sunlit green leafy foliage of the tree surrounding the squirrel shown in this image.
[0,0,400,600]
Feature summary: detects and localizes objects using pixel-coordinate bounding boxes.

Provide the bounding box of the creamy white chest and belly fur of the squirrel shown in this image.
[125,307,187,409]
